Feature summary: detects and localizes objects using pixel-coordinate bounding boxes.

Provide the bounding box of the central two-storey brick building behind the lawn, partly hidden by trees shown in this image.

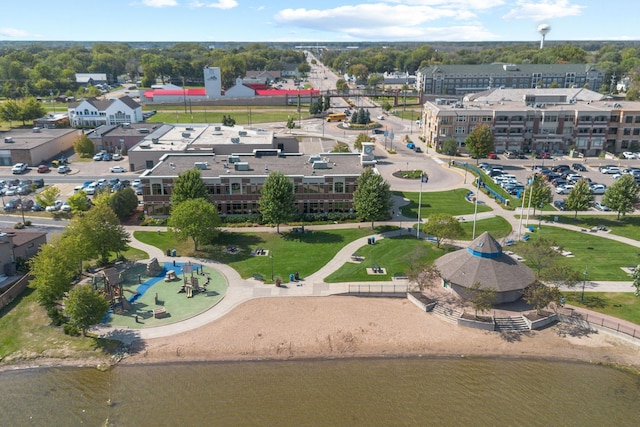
[140,143,375,216]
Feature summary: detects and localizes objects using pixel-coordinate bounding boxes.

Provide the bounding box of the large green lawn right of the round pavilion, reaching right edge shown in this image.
[511,225,640,281]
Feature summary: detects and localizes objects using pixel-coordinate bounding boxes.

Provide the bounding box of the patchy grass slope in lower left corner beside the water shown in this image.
[0,288,119,362]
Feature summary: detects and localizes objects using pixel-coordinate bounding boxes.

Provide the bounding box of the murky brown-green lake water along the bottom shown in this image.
[0,358,640,427]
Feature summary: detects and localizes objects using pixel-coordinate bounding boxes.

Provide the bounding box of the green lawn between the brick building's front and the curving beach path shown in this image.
[134,227,394,283]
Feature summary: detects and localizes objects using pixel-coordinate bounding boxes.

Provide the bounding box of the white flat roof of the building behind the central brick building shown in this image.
[130,123,273,152]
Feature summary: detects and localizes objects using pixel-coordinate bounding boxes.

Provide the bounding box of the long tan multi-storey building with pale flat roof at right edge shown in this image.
[421,88,640,156]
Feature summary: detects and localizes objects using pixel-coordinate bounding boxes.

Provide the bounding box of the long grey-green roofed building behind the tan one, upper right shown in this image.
[416,64,605,96]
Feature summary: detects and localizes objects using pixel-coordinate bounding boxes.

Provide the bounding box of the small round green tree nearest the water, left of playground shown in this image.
[65,285,109,335]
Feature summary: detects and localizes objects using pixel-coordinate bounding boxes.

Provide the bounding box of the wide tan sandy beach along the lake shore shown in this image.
[122,296,640,370]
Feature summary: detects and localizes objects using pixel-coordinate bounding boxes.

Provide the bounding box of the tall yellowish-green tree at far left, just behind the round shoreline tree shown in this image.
[29,235,78,310]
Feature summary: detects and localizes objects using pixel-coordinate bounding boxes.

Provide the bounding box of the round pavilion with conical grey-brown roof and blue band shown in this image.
[435,232,535,304]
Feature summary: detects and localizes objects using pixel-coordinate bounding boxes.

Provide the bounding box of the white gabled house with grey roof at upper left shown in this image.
[69,96,143,127]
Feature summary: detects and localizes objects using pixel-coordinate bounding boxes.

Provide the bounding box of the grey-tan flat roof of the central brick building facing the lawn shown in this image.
[141,153,363,180]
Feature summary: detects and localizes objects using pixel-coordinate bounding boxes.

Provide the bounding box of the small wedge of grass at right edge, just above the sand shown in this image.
[565,292,640,325]
